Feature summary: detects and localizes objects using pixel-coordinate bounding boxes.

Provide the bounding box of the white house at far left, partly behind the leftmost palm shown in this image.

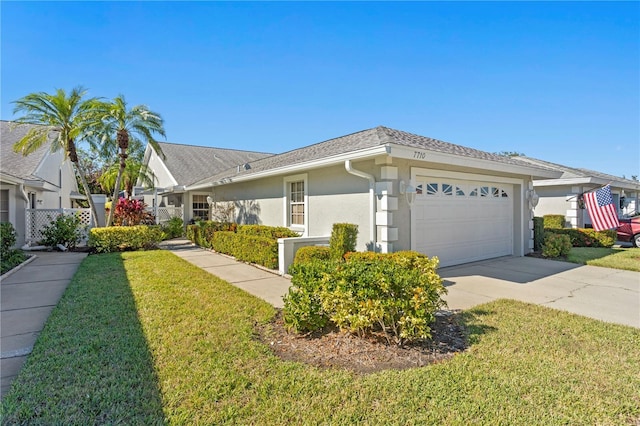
[0,121,85,246]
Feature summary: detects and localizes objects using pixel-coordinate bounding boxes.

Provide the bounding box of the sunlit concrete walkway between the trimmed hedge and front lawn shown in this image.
[160,239,291,308]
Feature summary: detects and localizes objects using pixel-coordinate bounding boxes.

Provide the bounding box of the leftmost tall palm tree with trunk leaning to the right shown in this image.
[13,86,99,226]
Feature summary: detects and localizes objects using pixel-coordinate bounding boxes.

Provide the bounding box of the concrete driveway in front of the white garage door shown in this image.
[439,257,640,328]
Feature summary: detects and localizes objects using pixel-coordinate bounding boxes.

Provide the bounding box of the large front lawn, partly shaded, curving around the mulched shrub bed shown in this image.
[0,251,640,425]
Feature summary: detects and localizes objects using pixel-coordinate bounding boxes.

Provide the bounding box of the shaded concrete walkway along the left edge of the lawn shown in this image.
[0,252,87,397]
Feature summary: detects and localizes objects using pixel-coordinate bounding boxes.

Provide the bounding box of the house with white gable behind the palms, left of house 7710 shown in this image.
[143,142,273,220]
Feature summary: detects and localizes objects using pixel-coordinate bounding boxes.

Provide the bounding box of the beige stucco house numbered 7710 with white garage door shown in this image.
[184,127,561,272]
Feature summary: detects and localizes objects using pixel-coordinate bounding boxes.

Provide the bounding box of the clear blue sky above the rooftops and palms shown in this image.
[0,1,640,177]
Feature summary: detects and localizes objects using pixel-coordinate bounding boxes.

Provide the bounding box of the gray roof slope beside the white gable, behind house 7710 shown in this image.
[158,142,273,185]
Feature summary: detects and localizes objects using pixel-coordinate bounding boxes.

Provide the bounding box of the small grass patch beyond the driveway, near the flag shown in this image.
[567,247,640,272]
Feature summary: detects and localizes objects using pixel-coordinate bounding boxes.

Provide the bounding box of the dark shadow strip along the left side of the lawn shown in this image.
[0,253,164,424]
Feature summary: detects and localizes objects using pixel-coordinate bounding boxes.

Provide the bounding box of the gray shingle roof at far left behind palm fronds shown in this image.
[0,121,53,180]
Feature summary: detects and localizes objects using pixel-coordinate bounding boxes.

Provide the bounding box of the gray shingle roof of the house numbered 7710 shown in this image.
[198,126,556,183]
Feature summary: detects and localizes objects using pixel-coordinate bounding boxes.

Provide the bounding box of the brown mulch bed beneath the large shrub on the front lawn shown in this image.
[256,311,468,374]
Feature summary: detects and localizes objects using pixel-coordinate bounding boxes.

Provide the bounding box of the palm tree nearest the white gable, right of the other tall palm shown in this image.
[96,95,165,226]
